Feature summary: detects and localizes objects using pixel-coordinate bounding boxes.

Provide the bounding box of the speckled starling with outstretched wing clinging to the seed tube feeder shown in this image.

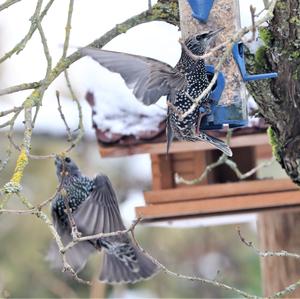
[81,28,232,156]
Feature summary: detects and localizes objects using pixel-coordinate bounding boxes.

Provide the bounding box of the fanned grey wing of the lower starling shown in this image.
[73,175,125,240]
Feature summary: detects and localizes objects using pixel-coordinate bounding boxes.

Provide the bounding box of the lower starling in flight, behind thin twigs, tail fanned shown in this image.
[47,156,159,284]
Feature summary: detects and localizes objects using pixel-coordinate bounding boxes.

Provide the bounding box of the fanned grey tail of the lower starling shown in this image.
[99,248,159,284]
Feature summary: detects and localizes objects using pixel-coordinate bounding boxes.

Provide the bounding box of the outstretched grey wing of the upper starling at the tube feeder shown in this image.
[80,48,187,105]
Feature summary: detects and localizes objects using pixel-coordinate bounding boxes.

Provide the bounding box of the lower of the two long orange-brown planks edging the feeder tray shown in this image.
[136,190,300,220]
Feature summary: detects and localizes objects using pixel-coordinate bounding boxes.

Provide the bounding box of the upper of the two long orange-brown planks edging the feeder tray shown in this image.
[144,179,300,204]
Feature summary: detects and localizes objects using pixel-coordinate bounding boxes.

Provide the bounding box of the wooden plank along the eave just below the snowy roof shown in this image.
[99,133,269,157]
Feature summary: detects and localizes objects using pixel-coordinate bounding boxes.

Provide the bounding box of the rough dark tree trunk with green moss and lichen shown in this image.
[247,0,300,185]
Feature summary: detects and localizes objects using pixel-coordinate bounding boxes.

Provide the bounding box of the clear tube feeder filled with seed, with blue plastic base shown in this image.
[179,0,248,130]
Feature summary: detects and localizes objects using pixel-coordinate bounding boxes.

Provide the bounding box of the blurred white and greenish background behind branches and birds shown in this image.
[0,0,284,298]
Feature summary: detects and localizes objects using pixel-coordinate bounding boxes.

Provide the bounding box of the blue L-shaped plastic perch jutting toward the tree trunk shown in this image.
[232,42,278,81]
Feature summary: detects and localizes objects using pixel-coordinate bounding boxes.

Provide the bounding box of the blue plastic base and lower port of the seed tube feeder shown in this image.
[200,65,248,130]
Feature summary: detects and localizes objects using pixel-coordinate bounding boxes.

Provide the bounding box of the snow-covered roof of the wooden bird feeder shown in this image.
[86,91,266,146]
